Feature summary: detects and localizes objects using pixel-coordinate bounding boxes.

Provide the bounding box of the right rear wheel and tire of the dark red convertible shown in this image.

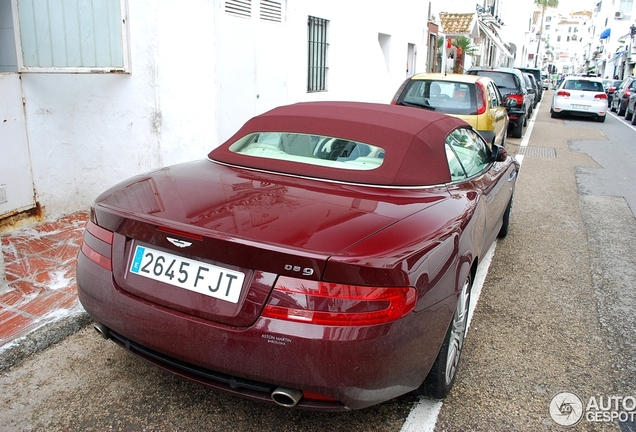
[416,274,473,399]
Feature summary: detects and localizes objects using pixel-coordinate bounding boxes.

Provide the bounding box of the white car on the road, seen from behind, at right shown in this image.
[550,76,607,122]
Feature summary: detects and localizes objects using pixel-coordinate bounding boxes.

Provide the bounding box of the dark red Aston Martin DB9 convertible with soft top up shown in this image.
[77,102,519,411]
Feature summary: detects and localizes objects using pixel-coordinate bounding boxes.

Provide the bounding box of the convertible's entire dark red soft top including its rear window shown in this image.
[208,102,468,187]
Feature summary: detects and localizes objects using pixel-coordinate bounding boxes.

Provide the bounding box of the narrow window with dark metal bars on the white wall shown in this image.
[307,16,329,92]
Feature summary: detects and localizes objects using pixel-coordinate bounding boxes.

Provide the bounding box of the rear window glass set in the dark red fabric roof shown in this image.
[230,132,385,170]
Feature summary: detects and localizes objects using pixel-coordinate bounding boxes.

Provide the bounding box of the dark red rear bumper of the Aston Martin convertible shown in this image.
[77,252,455,411]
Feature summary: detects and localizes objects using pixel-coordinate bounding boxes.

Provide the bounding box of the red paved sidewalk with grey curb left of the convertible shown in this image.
[0,212,90,370]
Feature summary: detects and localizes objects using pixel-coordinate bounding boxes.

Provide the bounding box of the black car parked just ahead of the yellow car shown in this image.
[466,67,532,138]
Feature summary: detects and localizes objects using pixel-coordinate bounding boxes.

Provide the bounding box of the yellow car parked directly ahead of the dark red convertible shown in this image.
[391,73,508,146]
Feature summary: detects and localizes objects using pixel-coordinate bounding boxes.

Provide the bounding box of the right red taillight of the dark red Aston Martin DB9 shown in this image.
[262,276,417,326]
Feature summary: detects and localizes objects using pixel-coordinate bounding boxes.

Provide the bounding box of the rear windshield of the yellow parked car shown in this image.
[399,80,477,115]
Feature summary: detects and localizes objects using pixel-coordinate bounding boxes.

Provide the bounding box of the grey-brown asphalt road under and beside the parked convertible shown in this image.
[0,92,636,432]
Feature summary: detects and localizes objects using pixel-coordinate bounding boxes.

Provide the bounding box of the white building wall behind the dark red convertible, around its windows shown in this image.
[14,0,428,217]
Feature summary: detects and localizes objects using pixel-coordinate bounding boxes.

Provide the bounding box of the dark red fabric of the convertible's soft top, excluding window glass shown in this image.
[208,102,469,186]
